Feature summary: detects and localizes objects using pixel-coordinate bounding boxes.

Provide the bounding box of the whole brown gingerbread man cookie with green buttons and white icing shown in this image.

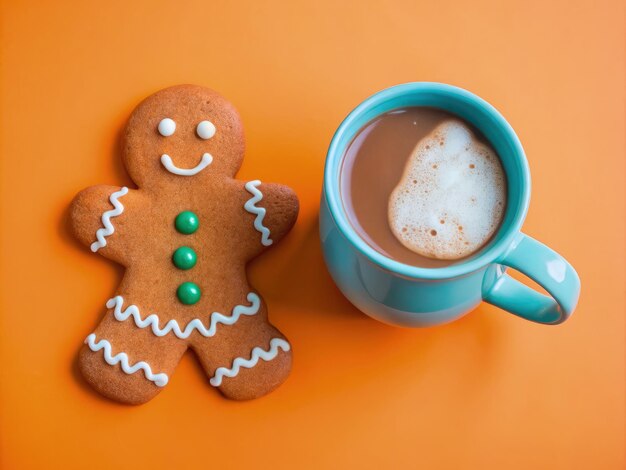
[70,85,298,404]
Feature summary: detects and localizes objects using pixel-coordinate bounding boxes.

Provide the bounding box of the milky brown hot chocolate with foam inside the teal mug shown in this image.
[340,107,506,268]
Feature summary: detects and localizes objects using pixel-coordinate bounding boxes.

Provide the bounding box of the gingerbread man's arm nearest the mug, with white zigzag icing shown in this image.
[239,180,300,247]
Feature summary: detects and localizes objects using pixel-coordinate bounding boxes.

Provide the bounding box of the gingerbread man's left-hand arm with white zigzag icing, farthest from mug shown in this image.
[69,185,135,261]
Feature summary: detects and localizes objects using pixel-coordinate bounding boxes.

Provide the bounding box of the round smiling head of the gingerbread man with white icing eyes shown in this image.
[123,85,244,187]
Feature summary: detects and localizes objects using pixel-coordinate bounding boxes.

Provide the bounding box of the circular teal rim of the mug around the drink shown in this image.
[323,82,530,280]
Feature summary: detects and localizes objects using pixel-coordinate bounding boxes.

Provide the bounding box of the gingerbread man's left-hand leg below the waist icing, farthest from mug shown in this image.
[78,311,187,405]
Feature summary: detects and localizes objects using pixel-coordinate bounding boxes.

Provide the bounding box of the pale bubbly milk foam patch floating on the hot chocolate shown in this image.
[388,120,506,259]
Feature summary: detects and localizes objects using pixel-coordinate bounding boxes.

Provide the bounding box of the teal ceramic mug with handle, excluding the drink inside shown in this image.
[320,82,580,327]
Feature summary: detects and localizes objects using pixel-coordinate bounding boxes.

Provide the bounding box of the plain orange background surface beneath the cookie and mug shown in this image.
[0,0,626,470]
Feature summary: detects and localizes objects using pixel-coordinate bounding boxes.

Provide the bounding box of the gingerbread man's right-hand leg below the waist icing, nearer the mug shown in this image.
[190,305,291,400]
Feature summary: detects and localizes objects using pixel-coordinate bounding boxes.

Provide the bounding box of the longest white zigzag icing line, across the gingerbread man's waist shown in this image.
[107,292,261,339]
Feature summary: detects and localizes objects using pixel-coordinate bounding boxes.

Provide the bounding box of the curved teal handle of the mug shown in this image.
[483,233,580,325]
